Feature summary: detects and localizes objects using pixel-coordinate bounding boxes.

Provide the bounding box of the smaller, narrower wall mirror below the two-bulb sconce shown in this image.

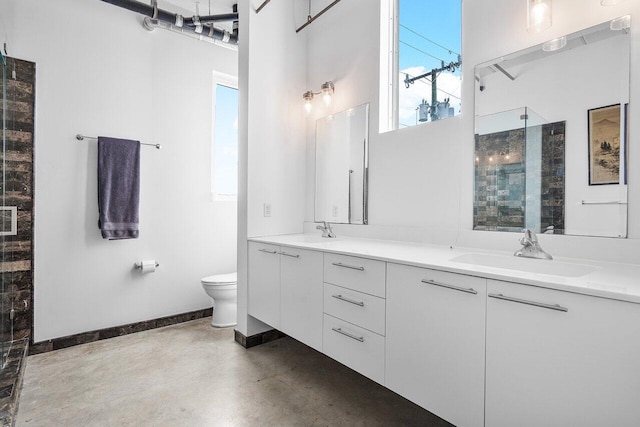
[314,104,369,224]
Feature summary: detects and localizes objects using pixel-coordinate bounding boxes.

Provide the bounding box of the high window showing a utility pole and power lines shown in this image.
[380,0,462,132]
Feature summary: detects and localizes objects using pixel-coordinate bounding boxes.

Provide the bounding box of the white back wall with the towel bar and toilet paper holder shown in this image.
[0,0,238,342]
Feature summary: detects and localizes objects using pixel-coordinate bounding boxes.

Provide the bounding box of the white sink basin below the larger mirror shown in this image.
[450,254,596,277]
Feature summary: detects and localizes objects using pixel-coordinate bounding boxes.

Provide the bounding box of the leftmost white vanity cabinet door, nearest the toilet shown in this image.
[247,242,280,329]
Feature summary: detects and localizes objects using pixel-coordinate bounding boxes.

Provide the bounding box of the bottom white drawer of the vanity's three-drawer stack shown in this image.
[322,314,384,384]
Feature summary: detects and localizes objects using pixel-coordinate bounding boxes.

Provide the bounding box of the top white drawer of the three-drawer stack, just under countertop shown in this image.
[324,253,386,298]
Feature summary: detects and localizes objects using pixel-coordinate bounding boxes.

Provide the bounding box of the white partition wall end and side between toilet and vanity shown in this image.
[236,0,307,336]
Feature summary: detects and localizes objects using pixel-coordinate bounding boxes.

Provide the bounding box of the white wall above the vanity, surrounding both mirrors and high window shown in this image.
[305,0,640,262]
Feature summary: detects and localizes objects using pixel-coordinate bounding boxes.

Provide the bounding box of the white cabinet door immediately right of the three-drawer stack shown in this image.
[386,264,484,427]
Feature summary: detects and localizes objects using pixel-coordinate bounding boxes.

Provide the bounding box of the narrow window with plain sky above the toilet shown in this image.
[212,73,238,201]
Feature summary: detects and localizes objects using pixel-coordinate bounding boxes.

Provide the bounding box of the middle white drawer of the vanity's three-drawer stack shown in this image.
[324,283,386,335]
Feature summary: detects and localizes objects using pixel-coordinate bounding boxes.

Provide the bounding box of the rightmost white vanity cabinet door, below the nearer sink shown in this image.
[486,281,640,427]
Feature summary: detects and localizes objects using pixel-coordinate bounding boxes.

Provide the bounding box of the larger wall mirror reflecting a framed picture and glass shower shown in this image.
[473,16,630,237]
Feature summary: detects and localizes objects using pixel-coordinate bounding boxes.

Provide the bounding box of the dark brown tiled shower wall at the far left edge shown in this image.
[0,50,35,372]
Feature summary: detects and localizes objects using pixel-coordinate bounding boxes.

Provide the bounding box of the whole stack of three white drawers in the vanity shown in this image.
[323,253,386,384]
